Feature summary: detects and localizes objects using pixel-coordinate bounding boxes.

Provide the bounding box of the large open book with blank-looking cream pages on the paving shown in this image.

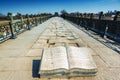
[39,46,97,77]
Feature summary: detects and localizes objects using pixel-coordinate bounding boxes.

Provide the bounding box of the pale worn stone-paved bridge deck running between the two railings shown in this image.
[0,18,120,80]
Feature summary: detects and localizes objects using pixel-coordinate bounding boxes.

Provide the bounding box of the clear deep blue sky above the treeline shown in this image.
[0,0,120,14]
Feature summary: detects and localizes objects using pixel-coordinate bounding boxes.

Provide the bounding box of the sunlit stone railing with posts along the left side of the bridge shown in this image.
[0,15,52,43]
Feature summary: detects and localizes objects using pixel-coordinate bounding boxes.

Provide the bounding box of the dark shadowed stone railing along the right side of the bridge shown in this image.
[63,15,120,42]
